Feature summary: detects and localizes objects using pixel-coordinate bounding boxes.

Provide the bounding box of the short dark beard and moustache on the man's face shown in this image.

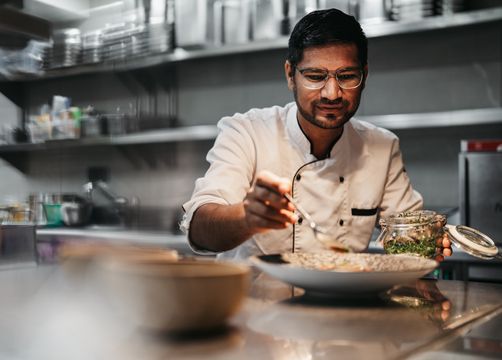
[293,87,358,129]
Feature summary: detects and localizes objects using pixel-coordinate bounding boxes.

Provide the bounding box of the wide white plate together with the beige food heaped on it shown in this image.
[251,252,438,297]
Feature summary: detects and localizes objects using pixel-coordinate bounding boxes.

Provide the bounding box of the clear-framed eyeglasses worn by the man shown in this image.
[297,68,363,90]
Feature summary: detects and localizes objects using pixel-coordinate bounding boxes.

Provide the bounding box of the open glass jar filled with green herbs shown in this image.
[377,210,446,258]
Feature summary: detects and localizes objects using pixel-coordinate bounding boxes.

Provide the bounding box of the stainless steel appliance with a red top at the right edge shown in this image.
[459,139,502,247]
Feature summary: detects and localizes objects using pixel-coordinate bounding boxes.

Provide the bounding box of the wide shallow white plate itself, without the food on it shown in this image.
[251,254,438,297]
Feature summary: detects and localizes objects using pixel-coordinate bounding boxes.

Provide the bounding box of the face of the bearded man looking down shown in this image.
[285,44,367,129]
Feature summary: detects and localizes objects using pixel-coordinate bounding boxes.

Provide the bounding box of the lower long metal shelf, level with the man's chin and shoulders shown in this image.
[0,108,502,156]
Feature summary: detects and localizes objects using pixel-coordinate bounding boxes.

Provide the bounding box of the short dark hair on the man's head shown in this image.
[287,9,368,67]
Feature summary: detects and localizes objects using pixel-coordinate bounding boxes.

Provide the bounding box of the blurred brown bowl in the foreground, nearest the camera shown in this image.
[103,257,249,332]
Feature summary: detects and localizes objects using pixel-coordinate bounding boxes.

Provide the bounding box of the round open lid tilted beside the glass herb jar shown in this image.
[445,224,502,259]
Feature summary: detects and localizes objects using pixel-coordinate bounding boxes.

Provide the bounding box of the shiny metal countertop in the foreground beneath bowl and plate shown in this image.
[0,266,502,360]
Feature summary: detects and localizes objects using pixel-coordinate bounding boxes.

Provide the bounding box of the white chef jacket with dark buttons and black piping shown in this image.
[181,103,423,259]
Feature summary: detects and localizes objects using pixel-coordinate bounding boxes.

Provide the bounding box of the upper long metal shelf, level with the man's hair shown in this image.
[0,7,502,81]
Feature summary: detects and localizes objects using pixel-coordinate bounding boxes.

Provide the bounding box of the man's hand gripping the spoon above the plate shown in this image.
[244,171,298,232]
